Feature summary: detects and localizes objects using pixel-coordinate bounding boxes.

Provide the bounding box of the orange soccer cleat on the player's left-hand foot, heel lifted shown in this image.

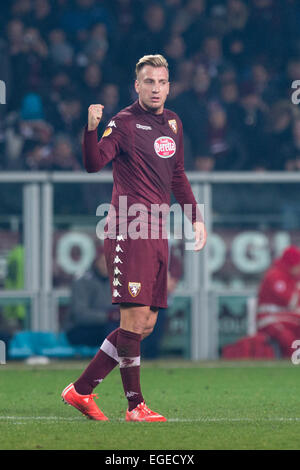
[61,383,108,421]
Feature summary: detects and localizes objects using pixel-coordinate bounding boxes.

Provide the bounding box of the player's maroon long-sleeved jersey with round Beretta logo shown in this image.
[83,101,202,237]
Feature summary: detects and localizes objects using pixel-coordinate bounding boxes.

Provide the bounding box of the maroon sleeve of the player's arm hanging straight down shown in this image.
[171,121,203,223]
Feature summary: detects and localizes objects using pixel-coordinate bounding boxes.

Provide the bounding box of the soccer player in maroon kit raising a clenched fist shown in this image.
[62,54,206,422]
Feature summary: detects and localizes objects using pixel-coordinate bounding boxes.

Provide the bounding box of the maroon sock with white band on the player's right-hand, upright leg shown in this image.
[117,328,144,411]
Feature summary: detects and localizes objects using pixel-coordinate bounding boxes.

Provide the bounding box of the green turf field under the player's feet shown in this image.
[0,361,300,450]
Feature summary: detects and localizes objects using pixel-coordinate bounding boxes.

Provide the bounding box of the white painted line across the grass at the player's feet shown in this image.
[0,416,300,424]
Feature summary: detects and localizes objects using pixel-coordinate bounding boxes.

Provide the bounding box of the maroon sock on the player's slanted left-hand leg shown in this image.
[74,328,119,395]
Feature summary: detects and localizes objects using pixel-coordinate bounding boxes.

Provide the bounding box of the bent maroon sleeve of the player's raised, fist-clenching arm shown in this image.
[82,116,128,173]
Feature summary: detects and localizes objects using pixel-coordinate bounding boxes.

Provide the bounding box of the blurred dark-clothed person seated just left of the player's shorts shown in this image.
[65,245,119,346]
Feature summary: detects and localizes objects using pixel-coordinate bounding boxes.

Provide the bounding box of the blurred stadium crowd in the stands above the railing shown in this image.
[0,0,300,171]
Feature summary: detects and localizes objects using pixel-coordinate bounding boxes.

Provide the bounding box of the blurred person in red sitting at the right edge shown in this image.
[222,245,300,359]
